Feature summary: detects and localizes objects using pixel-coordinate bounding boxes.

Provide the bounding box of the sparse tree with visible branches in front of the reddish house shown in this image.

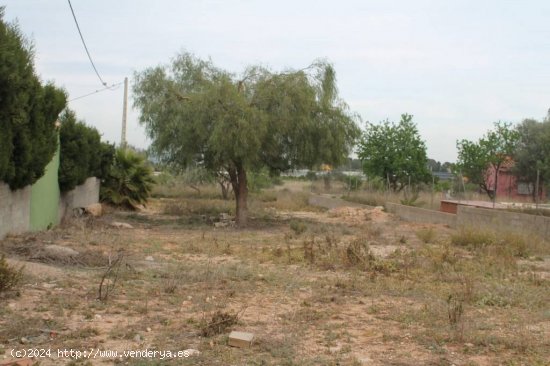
[456,122,519,201]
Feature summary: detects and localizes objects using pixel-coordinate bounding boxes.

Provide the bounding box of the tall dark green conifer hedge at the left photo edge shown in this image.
[0,7,66,189]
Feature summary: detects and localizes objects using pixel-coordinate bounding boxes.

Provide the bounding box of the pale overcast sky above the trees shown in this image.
[2,0,550,162]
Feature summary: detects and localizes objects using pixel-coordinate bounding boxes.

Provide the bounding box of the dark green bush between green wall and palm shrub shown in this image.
[59,109,115,191]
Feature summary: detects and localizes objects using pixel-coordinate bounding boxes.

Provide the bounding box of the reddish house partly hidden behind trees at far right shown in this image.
[485,159,546,201]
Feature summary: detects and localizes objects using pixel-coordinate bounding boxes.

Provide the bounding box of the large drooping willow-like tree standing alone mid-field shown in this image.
[133,53,359,225]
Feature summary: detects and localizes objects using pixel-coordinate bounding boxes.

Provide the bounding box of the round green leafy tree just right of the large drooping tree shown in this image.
[358,114,430,191]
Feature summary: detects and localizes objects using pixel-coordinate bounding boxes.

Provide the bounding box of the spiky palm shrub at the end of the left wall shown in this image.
[101,149,154,210]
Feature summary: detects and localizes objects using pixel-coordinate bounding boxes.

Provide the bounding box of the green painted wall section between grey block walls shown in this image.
[30,142,60,231]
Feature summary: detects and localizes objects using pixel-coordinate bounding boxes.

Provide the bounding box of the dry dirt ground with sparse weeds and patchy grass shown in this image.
[0,186,550,366]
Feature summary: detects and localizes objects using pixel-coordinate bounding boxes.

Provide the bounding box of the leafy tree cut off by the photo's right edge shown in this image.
[514,111,550,200]
